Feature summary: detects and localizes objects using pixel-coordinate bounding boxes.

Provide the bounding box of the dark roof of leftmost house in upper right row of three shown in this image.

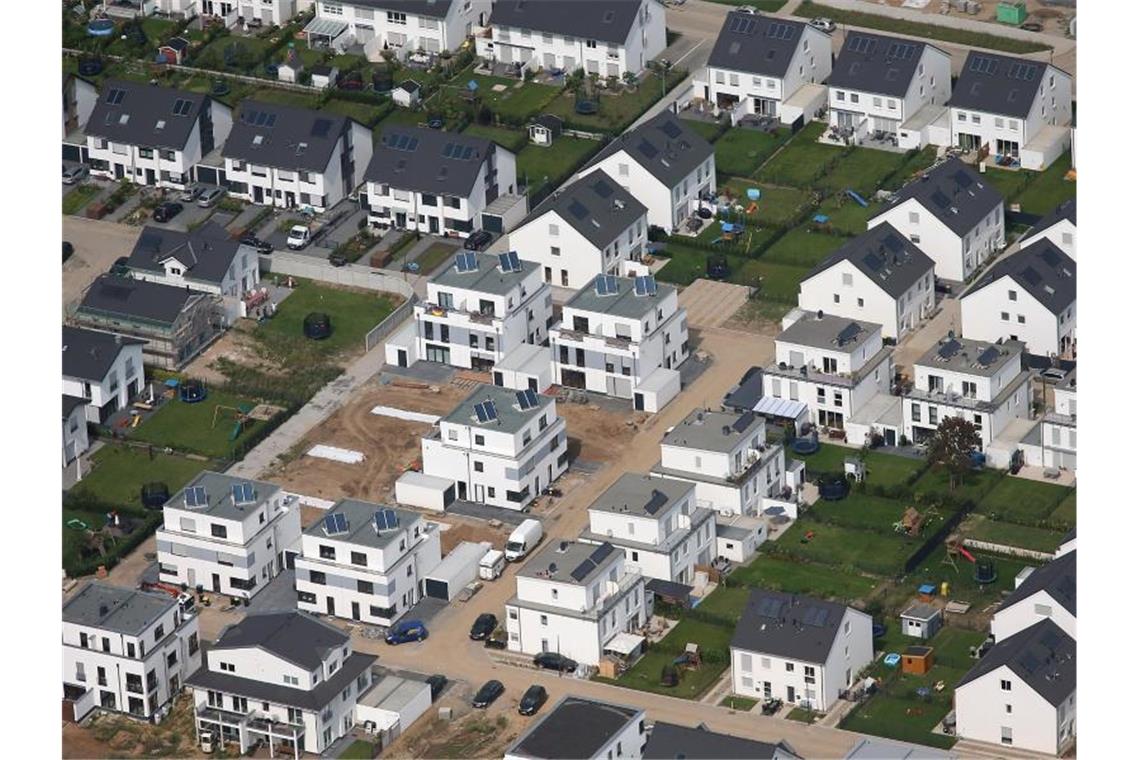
[708,10,823,79]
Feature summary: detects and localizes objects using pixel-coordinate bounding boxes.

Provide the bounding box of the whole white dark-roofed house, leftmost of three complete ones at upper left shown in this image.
[84,80,234,188]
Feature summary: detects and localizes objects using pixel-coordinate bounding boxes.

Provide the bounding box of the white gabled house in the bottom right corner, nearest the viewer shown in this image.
[954,620,1076,755]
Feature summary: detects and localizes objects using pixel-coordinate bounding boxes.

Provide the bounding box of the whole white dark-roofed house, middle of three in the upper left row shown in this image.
[221,100,372,213]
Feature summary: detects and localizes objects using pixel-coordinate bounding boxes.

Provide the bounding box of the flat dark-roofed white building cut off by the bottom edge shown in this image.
[503,694,652,760]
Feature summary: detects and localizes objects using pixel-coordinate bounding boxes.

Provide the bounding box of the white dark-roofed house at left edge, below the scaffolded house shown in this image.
[63,325,145,430]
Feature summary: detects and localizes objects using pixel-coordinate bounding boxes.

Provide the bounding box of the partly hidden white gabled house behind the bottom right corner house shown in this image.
[990,549,1076,641]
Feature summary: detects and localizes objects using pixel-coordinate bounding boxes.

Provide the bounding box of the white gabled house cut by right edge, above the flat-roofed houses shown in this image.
[960,237,1076,359]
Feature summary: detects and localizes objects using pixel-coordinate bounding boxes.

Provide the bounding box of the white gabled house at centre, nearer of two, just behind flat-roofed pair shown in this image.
[510,170,649,289]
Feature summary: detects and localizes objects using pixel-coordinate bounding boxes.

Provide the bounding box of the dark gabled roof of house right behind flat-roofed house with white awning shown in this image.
[804,222,934,299]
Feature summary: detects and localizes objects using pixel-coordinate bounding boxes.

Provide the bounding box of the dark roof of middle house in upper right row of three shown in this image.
[828,32,938,98]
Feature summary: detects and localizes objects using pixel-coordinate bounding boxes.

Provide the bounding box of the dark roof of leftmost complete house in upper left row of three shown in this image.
[86,80,211,150]
